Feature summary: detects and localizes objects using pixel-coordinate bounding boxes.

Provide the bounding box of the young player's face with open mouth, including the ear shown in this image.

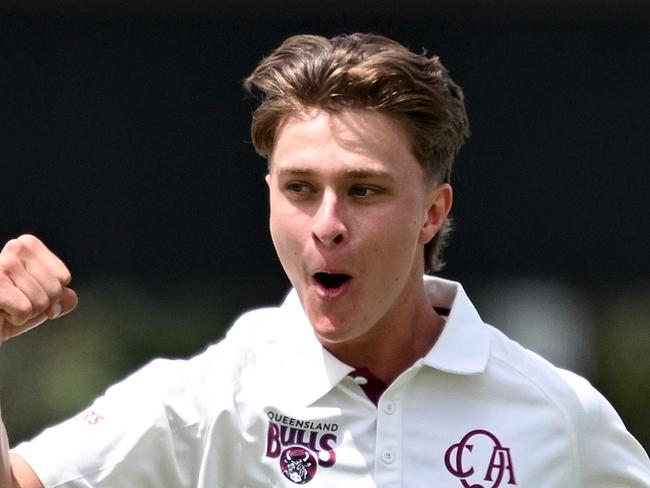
[267,109,451,350]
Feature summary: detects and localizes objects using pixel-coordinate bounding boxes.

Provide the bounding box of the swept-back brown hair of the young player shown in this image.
[244,34,469,272]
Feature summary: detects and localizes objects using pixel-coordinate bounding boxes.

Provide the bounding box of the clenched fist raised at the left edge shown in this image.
[0,235,78,342]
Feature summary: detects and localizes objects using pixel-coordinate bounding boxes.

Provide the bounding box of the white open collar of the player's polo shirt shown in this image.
[270,276,490,405]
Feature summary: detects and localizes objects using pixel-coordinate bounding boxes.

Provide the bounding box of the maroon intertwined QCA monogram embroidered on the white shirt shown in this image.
[445,429,517,488]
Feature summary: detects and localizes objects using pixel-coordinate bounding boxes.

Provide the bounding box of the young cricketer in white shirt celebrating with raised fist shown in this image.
[0,35,650,488]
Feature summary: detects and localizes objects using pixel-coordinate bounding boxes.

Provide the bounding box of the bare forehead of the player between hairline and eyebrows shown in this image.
[270,108,420,176]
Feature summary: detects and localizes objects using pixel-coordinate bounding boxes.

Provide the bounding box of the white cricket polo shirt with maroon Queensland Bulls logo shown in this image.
[15,277,650,488]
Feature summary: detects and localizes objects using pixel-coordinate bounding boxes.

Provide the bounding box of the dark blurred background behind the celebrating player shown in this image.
[0,0,650,448]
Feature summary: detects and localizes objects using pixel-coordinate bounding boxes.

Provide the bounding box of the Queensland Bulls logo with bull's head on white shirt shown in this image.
[266,411,339,485]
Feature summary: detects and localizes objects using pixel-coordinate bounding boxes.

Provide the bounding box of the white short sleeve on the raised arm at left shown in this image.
[14,344,238,488]
